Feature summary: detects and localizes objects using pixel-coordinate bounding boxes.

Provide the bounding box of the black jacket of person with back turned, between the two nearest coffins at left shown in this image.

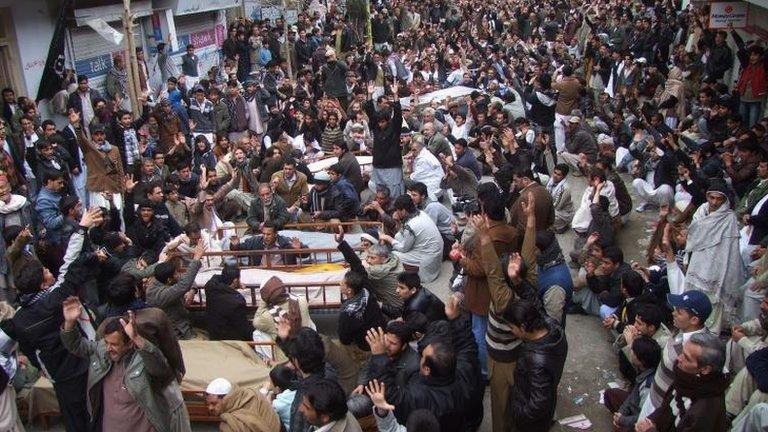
[204,275,253,340]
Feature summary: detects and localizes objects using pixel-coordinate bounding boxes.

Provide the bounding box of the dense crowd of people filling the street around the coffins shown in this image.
[0,0,768,432]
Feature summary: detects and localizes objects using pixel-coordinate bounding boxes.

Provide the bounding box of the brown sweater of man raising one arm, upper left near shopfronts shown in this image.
[77,128,124,193]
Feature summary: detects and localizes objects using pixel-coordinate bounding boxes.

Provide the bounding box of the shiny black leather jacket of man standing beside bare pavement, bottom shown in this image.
[509,321,568,431]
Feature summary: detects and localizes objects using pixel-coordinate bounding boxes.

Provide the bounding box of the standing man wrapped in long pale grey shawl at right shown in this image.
[683,181,746,334]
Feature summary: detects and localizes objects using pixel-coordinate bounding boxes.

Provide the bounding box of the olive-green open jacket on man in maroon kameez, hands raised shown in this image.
[61,327,190,432]
